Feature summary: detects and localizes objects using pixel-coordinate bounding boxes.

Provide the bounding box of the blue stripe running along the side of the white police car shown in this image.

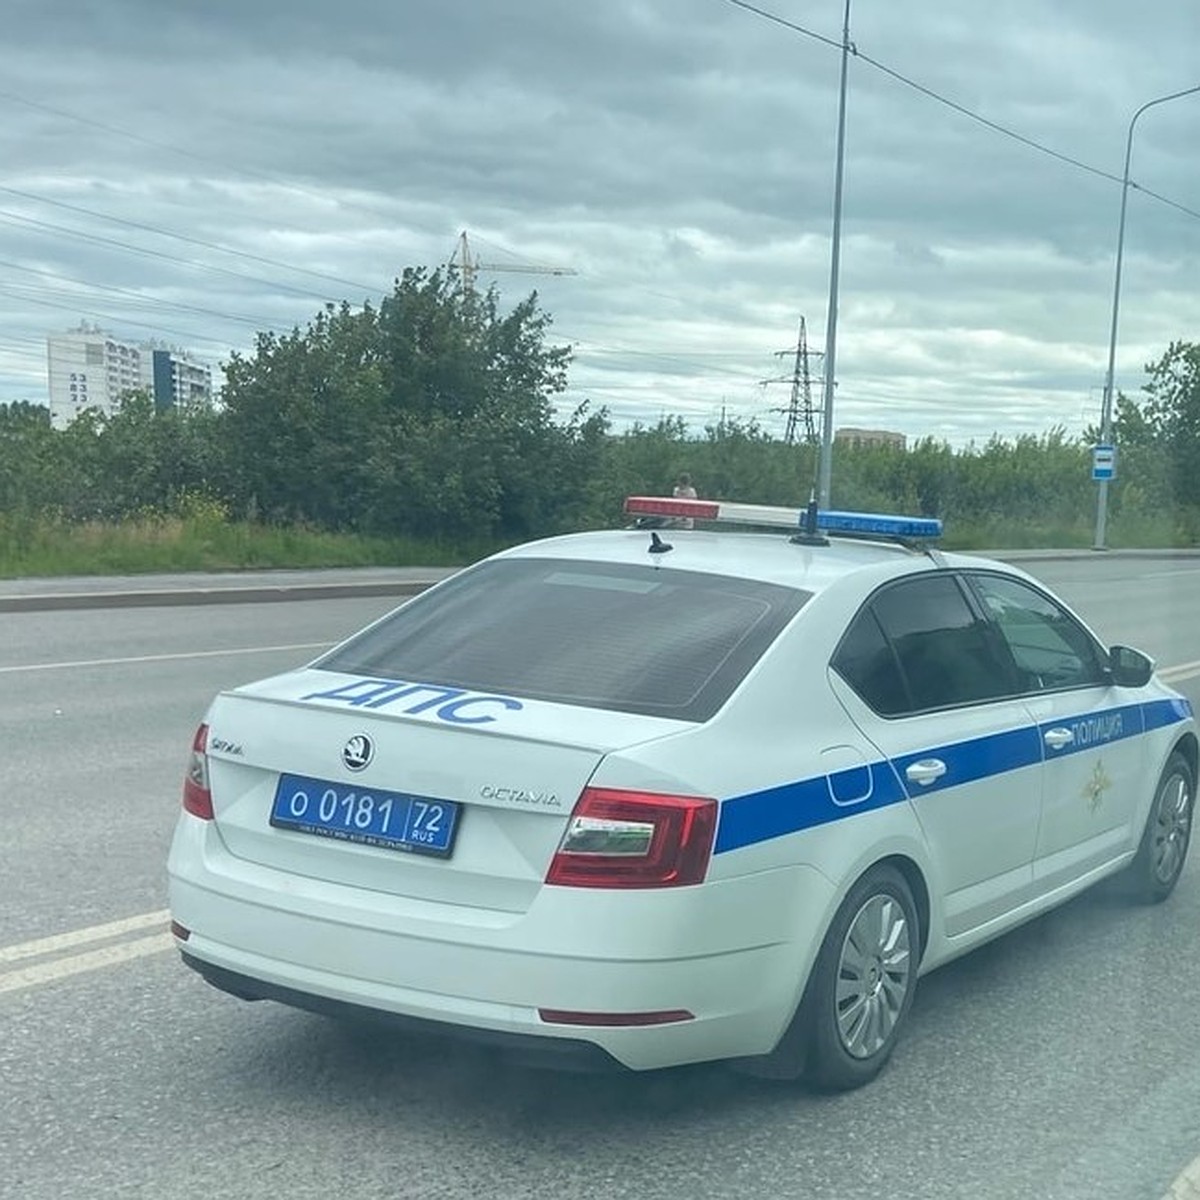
[713,698,1192,854]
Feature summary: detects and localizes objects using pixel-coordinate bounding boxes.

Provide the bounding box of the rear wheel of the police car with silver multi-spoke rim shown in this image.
[798,864,920,1092]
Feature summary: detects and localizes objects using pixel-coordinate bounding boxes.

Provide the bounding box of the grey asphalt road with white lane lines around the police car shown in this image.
[0,557,1200,1200]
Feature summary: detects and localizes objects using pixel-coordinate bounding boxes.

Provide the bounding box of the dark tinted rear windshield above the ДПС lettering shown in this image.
[314,558,811,721]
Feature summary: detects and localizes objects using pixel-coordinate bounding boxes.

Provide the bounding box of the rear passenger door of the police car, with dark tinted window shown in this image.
[832,570,1042,936]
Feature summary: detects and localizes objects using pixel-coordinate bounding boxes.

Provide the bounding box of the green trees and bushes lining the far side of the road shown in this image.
[0,268,1200,546]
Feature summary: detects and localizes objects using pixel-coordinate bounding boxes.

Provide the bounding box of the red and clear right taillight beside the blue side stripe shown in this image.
[546,787,716,888]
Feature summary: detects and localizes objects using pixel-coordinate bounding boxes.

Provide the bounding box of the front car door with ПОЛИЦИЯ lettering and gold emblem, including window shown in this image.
[968,572,1150,892]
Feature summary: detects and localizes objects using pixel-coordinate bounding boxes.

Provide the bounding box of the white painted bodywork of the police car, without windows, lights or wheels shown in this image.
[168,529,1195,1069]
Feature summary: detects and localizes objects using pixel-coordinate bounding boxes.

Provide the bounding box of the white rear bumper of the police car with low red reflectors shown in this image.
[168,816,832,1070]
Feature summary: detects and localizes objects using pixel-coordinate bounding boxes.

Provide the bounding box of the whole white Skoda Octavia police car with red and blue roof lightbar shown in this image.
[169,498,1198,1087]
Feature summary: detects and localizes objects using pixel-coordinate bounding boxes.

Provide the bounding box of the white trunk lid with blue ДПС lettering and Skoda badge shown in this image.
[201,668,692,912]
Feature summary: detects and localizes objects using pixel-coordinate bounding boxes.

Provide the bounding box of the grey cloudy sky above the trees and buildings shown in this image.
[0,0,1200,445]
